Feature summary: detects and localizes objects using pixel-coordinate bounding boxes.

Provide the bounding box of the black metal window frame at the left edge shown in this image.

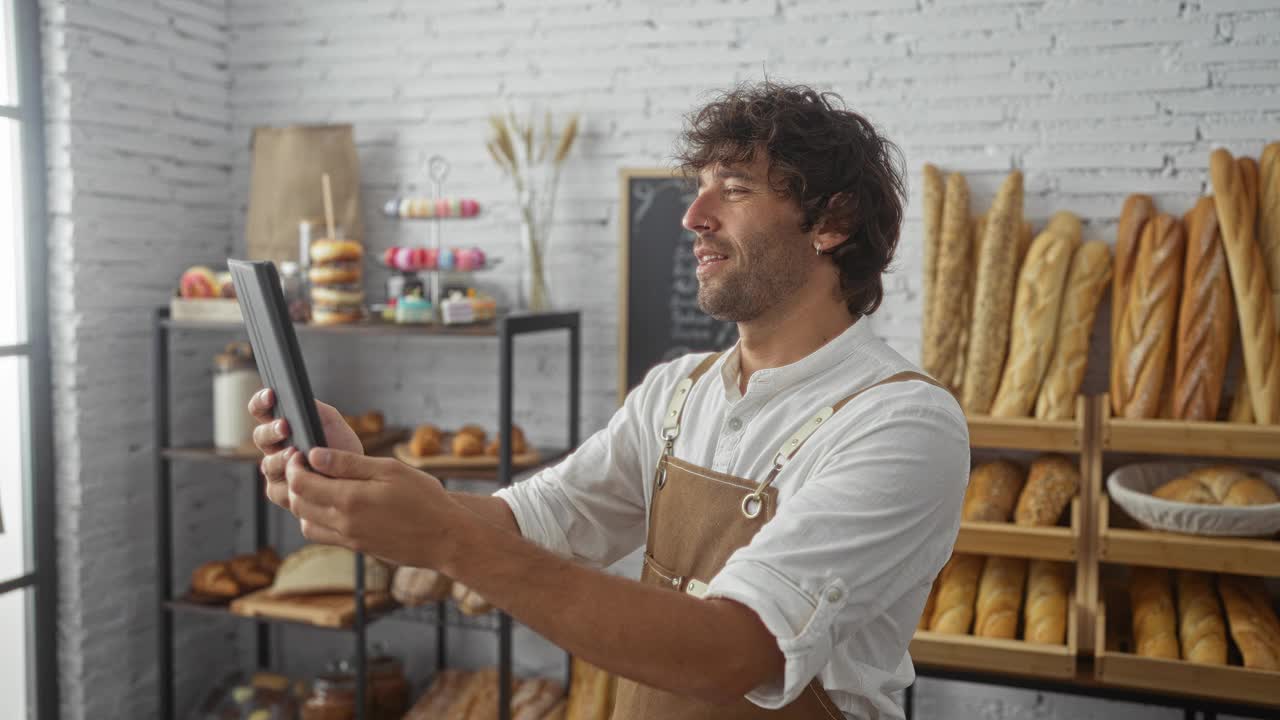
[0,0,59,719]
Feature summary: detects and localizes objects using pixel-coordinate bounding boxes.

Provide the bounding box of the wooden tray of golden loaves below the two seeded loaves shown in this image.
[911,553,1080,679]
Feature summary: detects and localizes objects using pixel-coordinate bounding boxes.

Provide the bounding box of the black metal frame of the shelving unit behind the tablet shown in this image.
[152,307,582,720]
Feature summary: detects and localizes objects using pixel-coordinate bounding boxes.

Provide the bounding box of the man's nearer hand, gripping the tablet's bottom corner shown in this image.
[284,447,458,569]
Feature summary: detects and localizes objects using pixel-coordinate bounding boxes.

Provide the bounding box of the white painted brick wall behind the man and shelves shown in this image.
[44,0,1280,717]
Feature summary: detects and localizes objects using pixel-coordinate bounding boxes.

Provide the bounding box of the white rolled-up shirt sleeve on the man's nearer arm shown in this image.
[708,391,969,708]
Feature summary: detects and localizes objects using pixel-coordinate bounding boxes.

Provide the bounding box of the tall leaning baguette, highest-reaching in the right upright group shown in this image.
[1210,149,1280,425]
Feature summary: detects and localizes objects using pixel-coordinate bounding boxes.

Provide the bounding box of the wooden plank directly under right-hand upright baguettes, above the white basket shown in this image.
[1102,416,1280,460]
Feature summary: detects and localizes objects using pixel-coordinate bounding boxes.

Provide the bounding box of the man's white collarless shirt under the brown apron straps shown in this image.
[497,320,969,719]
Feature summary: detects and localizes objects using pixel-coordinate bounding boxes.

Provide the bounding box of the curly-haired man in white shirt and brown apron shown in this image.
[250,83,969,719]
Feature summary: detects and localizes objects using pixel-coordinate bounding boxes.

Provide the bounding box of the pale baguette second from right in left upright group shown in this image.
[991,228,1080,418]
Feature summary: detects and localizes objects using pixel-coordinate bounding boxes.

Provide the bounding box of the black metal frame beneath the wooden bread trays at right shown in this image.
[904,666,1276,720]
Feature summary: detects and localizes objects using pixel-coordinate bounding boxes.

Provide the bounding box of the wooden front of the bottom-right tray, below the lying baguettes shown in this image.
[1093,603,1280,707]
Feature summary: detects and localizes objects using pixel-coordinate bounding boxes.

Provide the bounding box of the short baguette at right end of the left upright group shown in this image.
[1036,240,1111,420]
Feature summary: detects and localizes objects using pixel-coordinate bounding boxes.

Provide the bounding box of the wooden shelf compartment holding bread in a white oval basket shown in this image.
[1097,461,1280,577]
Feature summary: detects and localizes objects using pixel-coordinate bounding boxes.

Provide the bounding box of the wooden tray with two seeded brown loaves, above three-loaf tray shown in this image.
[955,455,1082,561]
